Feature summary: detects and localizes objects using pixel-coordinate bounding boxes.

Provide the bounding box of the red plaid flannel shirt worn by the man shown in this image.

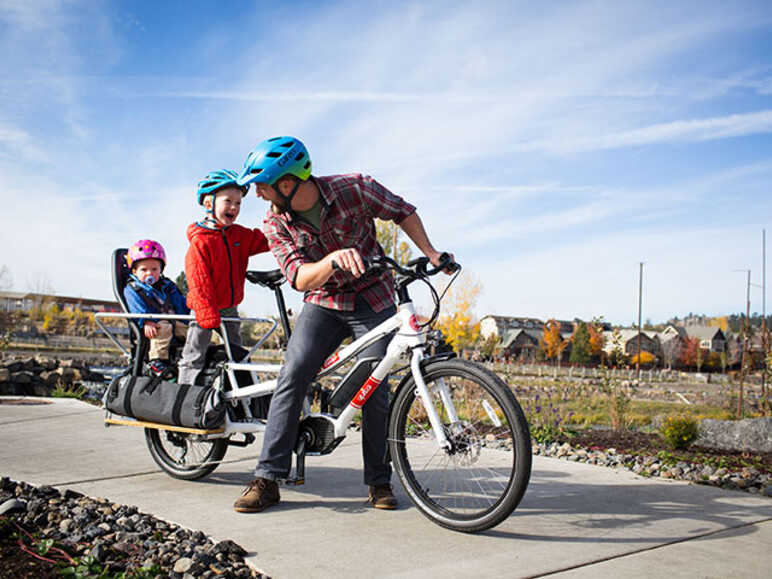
[263,174,415,312]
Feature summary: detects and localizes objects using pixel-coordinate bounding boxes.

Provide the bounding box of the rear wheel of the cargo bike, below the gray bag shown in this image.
[145,428,228,480]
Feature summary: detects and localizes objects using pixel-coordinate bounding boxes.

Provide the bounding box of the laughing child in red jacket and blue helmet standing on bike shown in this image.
[178,170,268,384]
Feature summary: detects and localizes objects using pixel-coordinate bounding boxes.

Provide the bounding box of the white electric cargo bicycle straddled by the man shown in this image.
[96,251,531,532]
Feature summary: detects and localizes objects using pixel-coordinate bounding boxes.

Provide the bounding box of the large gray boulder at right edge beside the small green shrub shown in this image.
[694,418,772,452]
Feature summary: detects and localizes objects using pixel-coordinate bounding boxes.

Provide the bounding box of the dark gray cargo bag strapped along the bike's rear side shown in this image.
[104,375,225,430]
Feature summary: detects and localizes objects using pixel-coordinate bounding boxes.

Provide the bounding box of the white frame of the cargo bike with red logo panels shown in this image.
[94,302,458,448]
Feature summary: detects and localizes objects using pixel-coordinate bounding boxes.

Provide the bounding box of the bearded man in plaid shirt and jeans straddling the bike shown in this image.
[234,137,452,512]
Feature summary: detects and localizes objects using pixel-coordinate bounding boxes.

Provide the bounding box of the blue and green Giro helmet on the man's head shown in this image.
[237,137,311,186]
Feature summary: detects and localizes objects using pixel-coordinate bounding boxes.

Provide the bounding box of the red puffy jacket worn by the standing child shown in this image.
[185,223,268,329]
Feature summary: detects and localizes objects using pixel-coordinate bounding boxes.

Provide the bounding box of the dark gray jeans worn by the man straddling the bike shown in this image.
[255,298,396,485]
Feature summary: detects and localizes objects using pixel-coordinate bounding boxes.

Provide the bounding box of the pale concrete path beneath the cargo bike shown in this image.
[0,398,772,578]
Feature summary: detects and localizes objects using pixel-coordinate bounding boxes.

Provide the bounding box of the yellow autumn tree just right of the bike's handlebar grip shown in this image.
[437,272,482,352]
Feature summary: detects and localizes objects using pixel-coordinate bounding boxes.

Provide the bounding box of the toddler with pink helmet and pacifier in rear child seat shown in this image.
[123,239,190,376]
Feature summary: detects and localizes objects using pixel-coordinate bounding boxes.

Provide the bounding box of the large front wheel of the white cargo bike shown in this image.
[389,360,531,532]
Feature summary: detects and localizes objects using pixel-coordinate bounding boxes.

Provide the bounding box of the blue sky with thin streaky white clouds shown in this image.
[0,0,772,323]
